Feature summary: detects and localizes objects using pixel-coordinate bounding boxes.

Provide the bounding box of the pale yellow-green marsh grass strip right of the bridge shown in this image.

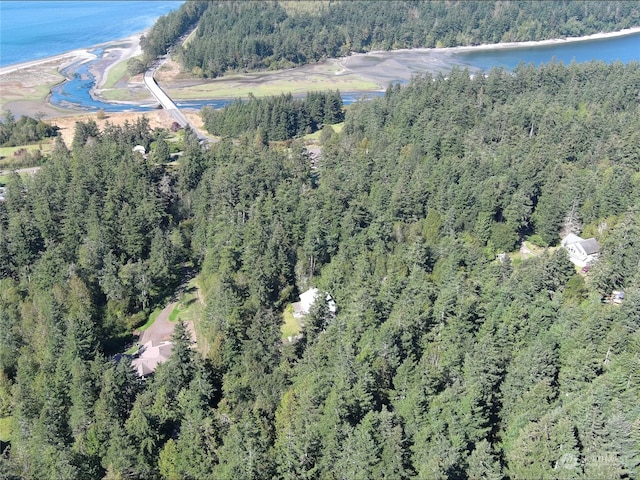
[168,75,380,100]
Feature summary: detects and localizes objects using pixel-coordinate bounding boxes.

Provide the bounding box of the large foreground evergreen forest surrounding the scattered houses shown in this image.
[0,63,640,479]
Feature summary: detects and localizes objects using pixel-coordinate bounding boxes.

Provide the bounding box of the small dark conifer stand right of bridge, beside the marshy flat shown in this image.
[201,91,344,142]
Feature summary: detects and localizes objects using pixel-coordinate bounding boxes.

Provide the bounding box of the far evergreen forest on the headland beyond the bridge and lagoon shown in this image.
[143,0,640,77]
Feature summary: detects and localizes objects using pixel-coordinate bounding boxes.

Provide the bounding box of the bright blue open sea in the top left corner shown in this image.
[0,0,183,67]
